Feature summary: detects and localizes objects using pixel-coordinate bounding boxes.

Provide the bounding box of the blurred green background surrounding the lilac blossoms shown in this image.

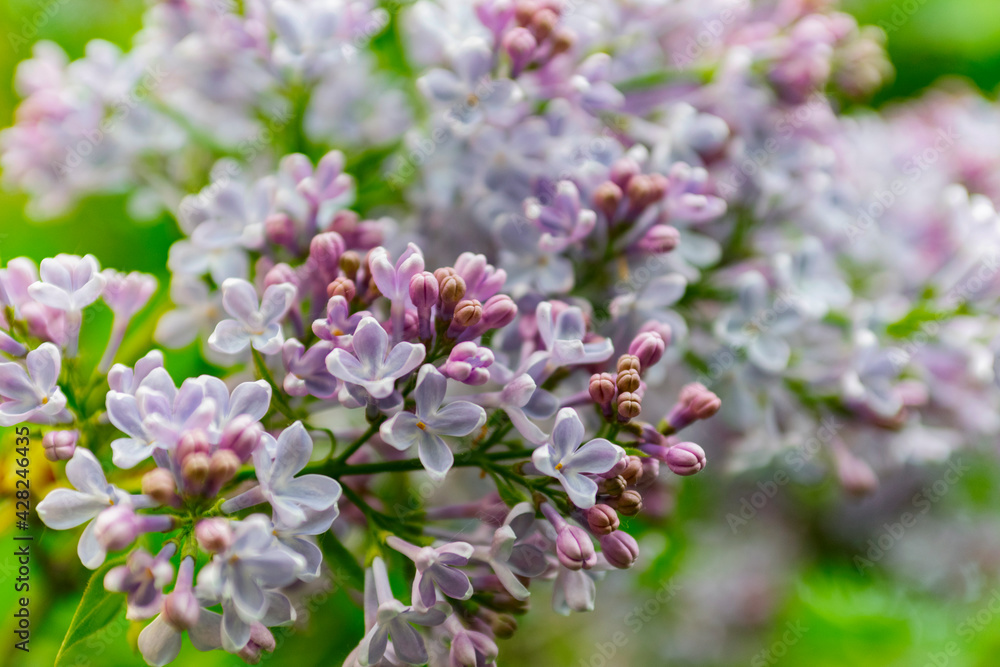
[0,0,1000,667]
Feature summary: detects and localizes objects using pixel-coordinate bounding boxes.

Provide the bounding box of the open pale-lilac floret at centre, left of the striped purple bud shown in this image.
[326,316,425,398]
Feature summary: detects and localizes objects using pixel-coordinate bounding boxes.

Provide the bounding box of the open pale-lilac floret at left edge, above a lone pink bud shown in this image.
[0,343,71,426]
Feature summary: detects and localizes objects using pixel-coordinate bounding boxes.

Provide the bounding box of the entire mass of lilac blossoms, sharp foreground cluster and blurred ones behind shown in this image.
[0,0,1000,666]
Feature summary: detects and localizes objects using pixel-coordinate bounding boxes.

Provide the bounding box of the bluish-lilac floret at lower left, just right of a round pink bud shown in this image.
[196,514,305,653]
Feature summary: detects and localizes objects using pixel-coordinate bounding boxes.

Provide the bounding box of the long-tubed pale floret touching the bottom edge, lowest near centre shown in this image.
[358,556,445,667]
